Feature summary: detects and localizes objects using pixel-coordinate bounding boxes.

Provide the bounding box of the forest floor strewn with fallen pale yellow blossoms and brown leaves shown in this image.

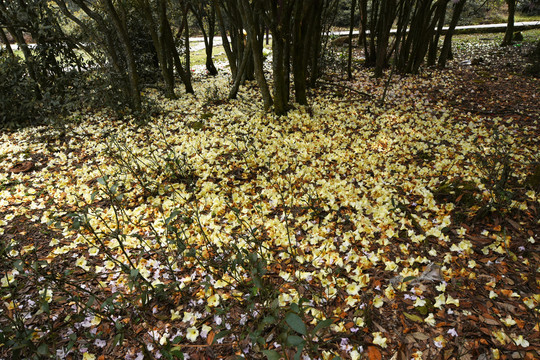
[0,31,540,360]
